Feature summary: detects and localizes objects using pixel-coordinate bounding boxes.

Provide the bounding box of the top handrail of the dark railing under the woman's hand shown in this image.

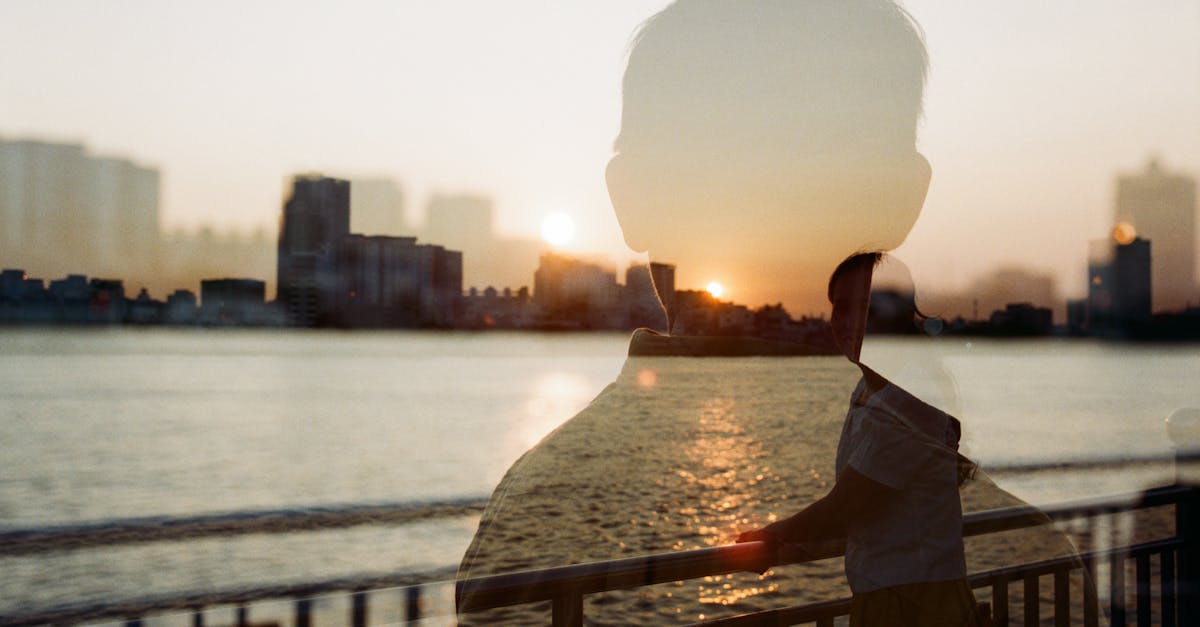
[456,485,1195,611]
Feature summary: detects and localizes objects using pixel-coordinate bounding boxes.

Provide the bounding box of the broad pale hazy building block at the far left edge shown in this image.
[0,139,160,281]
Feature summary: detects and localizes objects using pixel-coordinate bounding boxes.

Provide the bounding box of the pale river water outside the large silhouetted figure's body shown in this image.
[0,329,1200,614]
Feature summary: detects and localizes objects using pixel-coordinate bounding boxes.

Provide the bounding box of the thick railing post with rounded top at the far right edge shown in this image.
[1166,407,1200,625]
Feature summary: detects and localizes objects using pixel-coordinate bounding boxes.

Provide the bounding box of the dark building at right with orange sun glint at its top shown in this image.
[1087,238,1152,334]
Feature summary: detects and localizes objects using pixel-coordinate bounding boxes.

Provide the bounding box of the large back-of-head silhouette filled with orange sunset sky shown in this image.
[607,0,930,314]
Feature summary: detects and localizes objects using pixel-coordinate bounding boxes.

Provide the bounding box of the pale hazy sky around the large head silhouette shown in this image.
[0,0,1200,304]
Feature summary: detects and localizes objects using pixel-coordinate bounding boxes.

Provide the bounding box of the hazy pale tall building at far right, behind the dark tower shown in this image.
[1116,159,1198,311]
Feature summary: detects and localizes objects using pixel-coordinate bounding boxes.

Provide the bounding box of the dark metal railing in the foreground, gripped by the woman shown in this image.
[457,485,1200,627]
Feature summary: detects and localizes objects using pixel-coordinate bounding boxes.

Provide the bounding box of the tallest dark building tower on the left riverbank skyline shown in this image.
[276,174,350,327]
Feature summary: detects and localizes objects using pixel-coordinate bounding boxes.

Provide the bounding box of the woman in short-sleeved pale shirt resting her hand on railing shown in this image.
[738,253,979,627]
